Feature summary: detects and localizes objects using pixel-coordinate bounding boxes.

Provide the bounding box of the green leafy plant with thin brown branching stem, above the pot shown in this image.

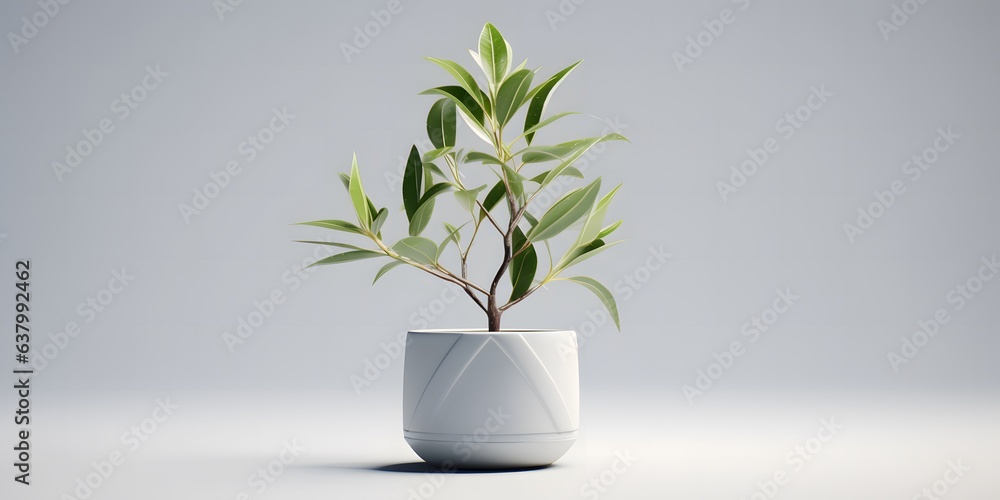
[292,24,626,331]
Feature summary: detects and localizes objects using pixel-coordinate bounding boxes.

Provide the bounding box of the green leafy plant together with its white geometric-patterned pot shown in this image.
[301,24,625,468]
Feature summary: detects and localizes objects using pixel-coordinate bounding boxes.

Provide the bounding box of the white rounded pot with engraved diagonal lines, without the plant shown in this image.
[403,330,580,469]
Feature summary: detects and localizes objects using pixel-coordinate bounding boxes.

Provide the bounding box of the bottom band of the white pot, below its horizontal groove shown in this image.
[403,431,577,470]
